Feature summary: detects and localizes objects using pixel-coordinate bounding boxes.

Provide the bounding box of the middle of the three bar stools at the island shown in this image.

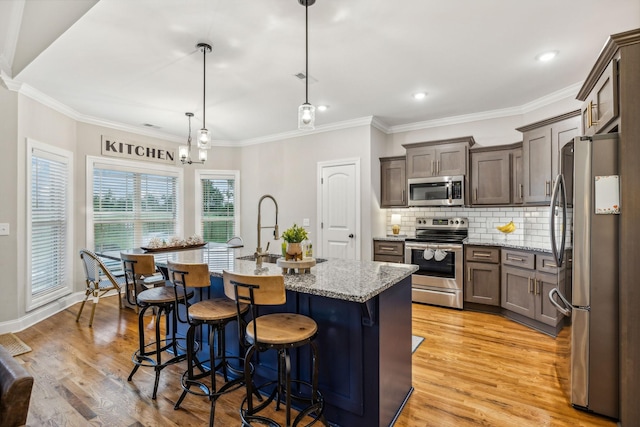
[167,261,249,427]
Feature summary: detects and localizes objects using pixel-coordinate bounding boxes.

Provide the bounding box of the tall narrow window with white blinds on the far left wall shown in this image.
[26,140,73,310]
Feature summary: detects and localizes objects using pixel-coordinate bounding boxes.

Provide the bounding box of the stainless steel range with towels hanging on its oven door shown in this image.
[404,218,469,309]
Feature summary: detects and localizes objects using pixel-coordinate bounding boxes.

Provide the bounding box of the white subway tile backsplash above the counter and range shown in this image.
[387,206,572,246]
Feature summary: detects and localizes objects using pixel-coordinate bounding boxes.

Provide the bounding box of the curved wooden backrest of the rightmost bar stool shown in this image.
[222,270,287,305]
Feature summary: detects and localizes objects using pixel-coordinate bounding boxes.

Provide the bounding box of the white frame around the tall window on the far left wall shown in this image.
[25,138,75,312]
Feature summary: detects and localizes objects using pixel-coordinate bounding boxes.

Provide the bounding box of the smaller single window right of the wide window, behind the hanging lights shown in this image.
[196,171,240,243]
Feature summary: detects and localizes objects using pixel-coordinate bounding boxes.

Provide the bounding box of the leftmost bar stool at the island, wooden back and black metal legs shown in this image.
[120,253,193,399]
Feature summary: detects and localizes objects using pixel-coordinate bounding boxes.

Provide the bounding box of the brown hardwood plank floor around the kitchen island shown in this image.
[16,297,616,427]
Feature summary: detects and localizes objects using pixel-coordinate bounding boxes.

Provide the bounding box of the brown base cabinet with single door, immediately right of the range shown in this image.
[464,246,500,306]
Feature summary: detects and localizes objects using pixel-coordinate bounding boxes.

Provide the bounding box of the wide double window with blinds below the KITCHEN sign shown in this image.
[87,158,182,258]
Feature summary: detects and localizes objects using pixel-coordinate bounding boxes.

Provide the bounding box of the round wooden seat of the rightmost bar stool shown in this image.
[247,313,318,345]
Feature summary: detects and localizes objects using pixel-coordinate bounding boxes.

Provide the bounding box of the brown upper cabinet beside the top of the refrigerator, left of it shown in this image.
[517,110,580,204]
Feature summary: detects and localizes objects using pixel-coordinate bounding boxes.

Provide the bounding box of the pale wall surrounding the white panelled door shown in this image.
[240,126,377,259]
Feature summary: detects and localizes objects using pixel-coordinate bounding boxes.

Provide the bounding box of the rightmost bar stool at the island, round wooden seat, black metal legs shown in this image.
[223,270,328,427]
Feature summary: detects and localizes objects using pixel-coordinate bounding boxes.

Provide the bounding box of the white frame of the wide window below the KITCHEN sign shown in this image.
[86,156,184,250]
